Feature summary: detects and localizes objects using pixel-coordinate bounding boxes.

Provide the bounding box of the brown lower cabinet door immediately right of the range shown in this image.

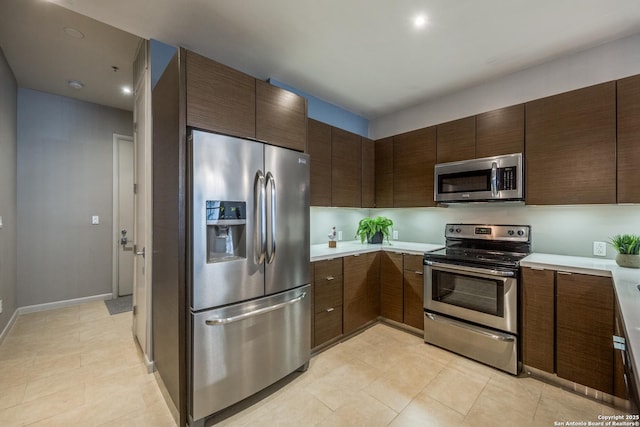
[522,268,556,373]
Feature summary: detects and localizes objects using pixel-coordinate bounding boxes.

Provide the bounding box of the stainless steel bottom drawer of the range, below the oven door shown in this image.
[424,312,518,375]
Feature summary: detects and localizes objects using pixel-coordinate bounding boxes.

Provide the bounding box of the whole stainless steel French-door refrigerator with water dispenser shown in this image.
[188,131,311,425]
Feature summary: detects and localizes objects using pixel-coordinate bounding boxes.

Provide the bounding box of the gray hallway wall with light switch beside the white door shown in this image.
[17,88,133,307]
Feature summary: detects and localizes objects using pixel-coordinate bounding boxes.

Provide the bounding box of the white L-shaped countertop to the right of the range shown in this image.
[520,253,640,396]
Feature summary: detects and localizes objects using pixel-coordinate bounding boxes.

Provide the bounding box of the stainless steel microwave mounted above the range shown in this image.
[434,153,524,203]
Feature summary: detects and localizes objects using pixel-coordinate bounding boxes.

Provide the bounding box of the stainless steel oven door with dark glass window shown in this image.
[424,261,518,334]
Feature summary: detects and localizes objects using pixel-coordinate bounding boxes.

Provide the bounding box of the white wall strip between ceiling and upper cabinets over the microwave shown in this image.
[369,34,640,139]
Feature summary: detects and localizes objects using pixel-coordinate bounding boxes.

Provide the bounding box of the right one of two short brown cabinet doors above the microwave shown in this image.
[476,104,524,158]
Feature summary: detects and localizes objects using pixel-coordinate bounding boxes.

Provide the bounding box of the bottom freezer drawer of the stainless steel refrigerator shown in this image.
[190,285,311,420]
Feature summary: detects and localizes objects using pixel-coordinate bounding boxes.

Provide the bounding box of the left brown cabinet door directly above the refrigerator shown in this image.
[185,51,256,138]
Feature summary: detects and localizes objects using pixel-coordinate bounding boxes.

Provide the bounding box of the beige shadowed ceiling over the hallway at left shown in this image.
[0,0,141,111]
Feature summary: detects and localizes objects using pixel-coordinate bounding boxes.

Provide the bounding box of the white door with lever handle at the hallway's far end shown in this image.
[114,135,135,297]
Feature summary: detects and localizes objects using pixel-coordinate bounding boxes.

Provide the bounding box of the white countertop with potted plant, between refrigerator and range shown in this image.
[311,240,444,262]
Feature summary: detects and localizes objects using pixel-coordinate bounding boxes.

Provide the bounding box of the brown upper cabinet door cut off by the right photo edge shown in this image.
[617,75,640,203]
